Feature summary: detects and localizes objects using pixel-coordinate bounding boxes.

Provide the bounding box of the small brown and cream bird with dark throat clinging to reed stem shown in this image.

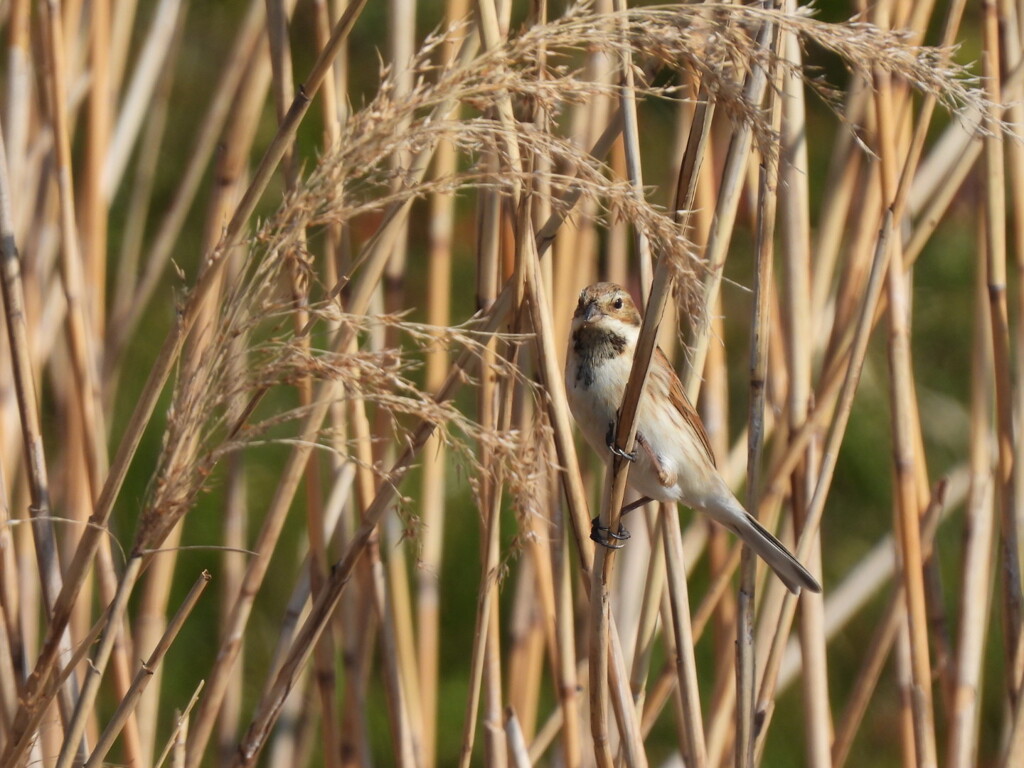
[565,283,821,594]
